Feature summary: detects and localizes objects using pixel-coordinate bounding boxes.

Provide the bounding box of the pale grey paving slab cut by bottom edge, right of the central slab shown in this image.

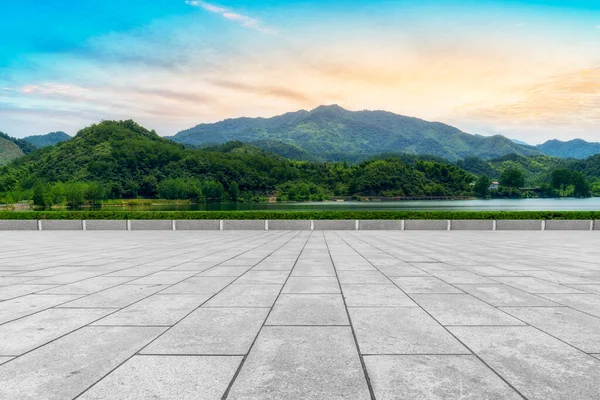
[365,355,522,400]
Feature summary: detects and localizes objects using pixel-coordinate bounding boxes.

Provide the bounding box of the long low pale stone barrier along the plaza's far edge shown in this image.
[0,220,600,231]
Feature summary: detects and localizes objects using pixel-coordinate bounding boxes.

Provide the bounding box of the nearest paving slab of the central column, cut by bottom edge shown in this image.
[227,326,370,400]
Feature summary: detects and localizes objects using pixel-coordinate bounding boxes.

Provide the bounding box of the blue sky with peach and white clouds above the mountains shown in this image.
[0,0,600,144]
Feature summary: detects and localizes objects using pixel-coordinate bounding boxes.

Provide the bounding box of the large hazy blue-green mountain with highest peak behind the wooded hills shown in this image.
[171,105,540,161]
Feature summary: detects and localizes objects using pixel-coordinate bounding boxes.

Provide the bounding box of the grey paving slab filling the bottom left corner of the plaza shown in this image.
[0,327,164,400]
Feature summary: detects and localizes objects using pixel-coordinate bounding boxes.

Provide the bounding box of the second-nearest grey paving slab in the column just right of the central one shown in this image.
[348,307,470,354]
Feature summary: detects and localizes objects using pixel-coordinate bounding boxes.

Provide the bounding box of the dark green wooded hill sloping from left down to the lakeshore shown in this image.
[0,121,475,200]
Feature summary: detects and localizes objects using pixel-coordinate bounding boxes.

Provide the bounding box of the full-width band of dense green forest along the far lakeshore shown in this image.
[0,121,600,206]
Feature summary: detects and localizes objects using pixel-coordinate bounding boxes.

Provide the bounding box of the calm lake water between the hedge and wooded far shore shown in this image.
[64,197,600,211]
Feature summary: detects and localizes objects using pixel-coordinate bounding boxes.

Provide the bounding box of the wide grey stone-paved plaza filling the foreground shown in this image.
[0,231,600,400]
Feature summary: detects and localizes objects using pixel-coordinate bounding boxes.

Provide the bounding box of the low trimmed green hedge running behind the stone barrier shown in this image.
[0,211,600,220]
